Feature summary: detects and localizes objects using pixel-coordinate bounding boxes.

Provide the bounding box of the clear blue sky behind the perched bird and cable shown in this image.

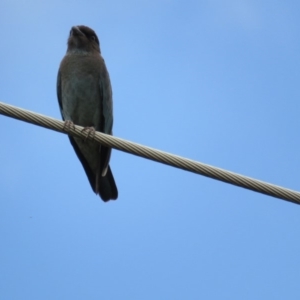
[0,0,300,300]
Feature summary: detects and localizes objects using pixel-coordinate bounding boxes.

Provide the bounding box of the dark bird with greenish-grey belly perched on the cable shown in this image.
[57,25,118,202]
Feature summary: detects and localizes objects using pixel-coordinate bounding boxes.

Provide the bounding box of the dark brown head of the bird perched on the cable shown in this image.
[67,25,100,53]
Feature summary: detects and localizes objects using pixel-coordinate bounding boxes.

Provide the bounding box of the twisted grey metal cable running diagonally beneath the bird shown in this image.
[0,102,300,204]
